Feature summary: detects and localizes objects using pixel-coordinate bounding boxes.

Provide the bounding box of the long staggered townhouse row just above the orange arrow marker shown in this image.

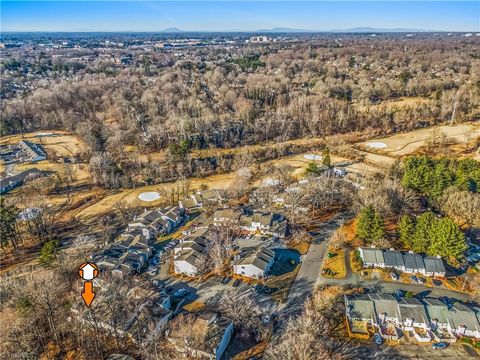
[92,207,185,275]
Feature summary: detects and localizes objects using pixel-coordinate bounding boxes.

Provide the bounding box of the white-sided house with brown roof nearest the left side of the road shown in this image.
[233,248,275,279]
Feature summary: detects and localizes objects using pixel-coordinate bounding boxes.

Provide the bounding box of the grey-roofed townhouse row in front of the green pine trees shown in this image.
[358,247,446,277]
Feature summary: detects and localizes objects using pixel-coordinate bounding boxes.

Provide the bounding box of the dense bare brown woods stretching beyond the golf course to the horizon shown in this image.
[2,35,480,188]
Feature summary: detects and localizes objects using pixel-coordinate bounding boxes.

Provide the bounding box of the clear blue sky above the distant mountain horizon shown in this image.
[0,0,480,31]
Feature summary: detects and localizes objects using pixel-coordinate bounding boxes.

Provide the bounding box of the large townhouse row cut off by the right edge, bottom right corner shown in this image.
[345,294,480,342]
